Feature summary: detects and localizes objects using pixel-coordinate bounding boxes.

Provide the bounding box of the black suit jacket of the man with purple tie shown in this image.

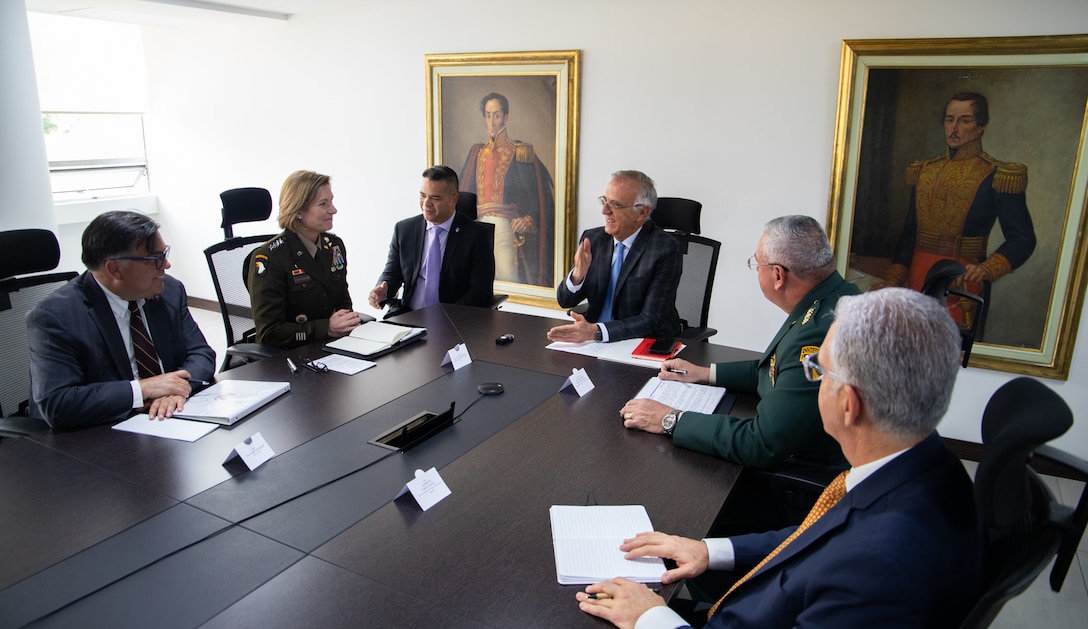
[378,212,495,315]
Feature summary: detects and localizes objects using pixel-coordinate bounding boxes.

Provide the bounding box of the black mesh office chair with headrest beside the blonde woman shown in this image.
[205,188,280,371]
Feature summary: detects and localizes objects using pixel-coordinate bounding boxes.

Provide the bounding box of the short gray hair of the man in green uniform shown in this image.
[762,214,834,280]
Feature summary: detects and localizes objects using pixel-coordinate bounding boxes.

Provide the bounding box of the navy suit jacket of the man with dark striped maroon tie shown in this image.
[26,272,215,429]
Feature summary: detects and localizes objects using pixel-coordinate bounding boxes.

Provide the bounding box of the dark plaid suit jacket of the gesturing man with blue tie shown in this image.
[556,221,683,341]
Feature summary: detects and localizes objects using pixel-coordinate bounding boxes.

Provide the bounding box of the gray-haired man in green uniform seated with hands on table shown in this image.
[620,215,860,534]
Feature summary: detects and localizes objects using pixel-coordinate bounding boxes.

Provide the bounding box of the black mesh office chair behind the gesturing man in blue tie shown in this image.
[651,197,721,343]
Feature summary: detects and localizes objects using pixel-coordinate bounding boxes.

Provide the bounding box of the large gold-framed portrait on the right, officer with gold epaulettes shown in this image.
[828,35,1088,380]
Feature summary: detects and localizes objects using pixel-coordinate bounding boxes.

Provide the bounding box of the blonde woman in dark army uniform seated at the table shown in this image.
[247,171,360,348]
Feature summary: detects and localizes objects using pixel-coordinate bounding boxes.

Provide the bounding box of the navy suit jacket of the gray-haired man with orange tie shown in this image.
[706,433,984,629]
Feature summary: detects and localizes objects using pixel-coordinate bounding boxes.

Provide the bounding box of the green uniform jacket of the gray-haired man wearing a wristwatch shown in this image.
[672,271,858,469]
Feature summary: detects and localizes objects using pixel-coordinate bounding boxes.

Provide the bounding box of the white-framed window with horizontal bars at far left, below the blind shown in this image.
[41,112,149,200]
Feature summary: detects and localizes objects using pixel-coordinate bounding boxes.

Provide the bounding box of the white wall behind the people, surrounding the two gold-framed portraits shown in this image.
[116,0,1088,457]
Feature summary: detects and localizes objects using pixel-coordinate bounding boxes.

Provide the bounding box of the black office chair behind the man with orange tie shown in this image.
[961,378,1088,629]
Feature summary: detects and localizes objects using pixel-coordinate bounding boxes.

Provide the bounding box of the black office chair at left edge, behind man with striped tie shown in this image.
[0,230,77,439]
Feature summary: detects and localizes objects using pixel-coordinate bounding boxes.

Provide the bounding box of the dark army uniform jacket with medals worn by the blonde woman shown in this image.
[246,230,351,348]
